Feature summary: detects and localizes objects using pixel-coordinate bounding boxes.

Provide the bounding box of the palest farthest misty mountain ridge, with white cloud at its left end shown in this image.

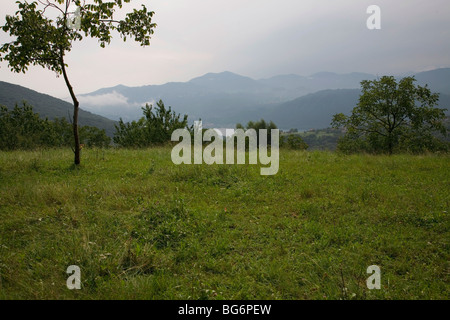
[80,72,375,126]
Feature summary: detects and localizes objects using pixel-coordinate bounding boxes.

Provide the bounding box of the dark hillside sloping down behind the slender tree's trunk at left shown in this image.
[0,81,115,137]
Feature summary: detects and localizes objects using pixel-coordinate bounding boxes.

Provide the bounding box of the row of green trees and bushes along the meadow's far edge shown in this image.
[0,76,450,154]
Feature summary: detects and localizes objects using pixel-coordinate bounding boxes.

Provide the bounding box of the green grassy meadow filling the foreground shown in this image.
[0,148,450,299]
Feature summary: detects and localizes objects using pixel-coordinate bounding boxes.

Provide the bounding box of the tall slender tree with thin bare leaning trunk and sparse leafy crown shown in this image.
[0,0,156,165]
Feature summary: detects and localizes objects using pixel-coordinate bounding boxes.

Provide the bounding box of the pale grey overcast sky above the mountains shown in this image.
[0,0,450,98]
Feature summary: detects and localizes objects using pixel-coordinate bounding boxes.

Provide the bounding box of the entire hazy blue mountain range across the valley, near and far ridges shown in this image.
[80,68,450,129]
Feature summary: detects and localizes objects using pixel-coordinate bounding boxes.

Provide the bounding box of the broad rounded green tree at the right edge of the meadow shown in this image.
[332,76,446,154]
